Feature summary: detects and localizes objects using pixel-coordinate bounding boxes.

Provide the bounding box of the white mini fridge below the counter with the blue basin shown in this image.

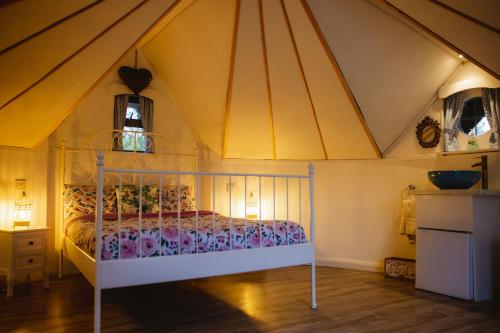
[415,228,474,300]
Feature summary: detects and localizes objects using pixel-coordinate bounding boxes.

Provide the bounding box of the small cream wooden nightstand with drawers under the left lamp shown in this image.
[0,227,50,297]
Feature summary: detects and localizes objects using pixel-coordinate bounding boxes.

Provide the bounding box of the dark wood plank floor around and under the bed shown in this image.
[0,267,500,332]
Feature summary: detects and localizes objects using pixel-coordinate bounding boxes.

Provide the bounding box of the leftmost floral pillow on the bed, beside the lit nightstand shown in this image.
[63,185,117,219]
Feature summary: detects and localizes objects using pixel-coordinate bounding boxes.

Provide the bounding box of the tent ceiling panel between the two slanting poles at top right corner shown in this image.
[389,0,500,78]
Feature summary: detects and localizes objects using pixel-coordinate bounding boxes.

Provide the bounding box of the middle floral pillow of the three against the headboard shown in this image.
[116,185,160,213]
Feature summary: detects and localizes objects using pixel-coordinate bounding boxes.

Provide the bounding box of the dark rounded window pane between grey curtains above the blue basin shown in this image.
[458,97,491,136]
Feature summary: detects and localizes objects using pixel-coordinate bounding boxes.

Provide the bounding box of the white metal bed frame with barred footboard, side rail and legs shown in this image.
[59,131,317,332]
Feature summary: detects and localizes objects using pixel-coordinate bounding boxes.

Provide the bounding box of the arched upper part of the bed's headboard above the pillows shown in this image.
[58,129,201,185]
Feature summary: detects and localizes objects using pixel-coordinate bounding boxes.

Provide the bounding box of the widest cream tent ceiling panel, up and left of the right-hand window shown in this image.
[308,0,459,151]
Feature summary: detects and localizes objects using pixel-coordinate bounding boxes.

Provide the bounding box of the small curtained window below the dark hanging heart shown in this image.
[113,95,153,152]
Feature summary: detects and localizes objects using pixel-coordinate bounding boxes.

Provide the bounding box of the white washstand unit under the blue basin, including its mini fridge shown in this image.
[415,190,500,301]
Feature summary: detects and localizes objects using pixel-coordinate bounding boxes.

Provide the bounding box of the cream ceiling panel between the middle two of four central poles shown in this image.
[263,1,326,159]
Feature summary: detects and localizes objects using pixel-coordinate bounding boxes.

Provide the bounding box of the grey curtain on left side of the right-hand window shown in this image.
[443,91,465,151]
